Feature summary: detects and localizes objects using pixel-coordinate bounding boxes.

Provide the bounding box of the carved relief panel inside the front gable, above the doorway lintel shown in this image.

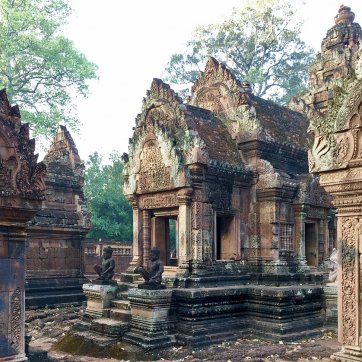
[138,140,172,192]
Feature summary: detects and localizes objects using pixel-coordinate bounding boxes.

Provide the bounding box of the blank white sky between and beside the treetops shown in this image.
[59,0,362,161]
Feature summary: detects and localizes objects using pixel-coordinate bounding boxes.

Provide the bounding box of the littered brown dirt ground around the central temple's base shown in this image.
[26,307,340,362]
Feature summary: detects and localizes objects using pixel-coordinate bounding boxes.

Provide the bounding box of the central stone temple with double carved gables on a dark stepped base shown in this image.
[119,58,335,348]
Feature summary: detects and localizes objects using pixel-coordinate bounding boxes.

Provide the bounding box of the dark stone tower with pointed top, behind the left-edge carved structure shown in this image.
[26,126,90,307]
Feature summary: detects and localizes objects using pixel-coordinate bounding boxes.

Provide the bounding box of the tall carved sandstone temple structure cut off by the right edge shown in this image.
[294,5,362,361]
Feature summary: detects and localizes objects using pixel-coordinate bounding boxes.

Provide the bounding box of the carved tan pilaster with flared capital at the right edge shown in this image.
[321,168,362,362]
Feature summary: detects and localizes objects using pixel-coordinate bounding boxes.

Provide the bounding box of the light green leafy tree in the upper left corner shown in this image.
[0,0,97,138]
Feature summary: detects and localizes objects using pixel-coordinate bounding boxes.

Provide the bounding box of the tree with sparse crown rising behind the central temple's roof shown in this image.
[165,0,314,104]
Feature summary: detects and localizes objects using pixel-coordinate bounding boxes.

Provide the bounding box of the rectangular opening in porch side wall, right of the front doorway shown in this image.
[215,215,237,260]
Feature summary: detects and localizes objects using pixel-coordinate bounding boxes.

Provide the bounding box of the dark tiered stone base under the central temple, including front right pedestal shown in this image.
[125,285,323,349]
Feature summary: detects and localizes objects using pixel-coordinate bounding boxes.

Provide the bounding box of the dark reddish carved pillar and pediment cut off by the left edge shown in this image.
[0,90,46,362]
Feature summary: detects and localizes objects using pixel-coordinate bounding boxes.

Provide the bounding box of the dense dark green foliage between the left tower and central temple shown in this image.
[84,152,133,241]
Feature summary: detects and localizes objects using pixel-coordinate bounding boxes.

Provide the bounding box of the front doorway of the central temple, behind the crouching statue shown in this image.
[152,215,179,266]
